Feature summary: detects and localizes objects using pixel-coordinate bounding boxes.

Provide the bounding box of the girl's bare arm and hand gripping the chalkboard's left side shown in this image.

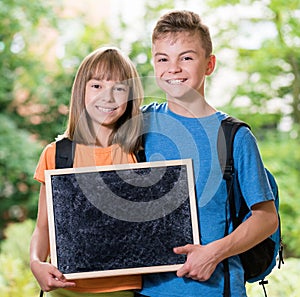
[30,184,75,292]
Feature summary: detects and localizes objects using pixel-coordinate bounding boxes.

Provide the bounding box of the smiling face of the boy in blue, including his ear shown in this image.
[152,32,215,100]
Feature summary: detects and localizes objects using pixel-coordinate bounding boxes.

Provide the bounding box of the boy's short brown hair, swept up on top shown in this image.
[152,10,212,57]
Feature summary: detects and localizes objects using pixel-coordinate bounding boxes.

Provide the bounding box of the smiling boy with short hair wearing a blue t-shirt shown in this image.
[141,11,278,297]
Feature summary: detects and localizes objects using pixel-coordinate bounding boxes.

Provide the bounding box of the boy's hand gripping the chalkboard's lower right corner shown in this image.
[174,244,218,281]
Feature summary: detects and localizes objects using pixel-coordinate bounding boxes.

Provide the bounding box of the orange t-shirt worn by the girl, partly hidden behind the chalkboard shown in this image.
[34,142,142,293]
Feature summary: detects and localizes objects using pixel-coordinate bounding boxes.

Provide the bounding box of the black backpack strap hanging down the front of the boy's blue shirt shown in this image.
[217,117,250,297]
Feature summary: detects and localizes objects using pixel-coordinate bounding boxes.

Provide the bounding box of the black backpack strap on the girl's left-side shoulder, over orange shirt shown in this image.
[55,138,75,169]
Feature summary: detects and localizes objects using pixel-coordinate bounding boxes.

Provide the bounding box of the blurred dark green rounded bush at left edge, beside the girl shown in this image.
[0,114,40,239]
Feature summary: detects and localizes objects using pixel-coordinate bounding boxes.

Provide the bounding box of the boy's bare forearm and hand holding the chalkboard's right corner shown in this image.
[174,201,278,281]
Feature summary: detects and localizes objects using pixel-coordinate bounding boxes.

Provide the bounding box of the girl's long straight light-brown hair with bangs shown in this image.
[64,47,143,153]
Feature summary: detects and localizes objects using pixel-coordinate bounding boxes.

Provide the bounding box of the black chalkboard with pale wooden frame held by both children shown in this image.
[45,159,199,279]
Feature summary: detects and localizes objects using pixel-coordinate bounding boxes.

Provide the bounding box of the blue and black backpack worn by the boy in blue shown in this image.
[217,117,284,296]
